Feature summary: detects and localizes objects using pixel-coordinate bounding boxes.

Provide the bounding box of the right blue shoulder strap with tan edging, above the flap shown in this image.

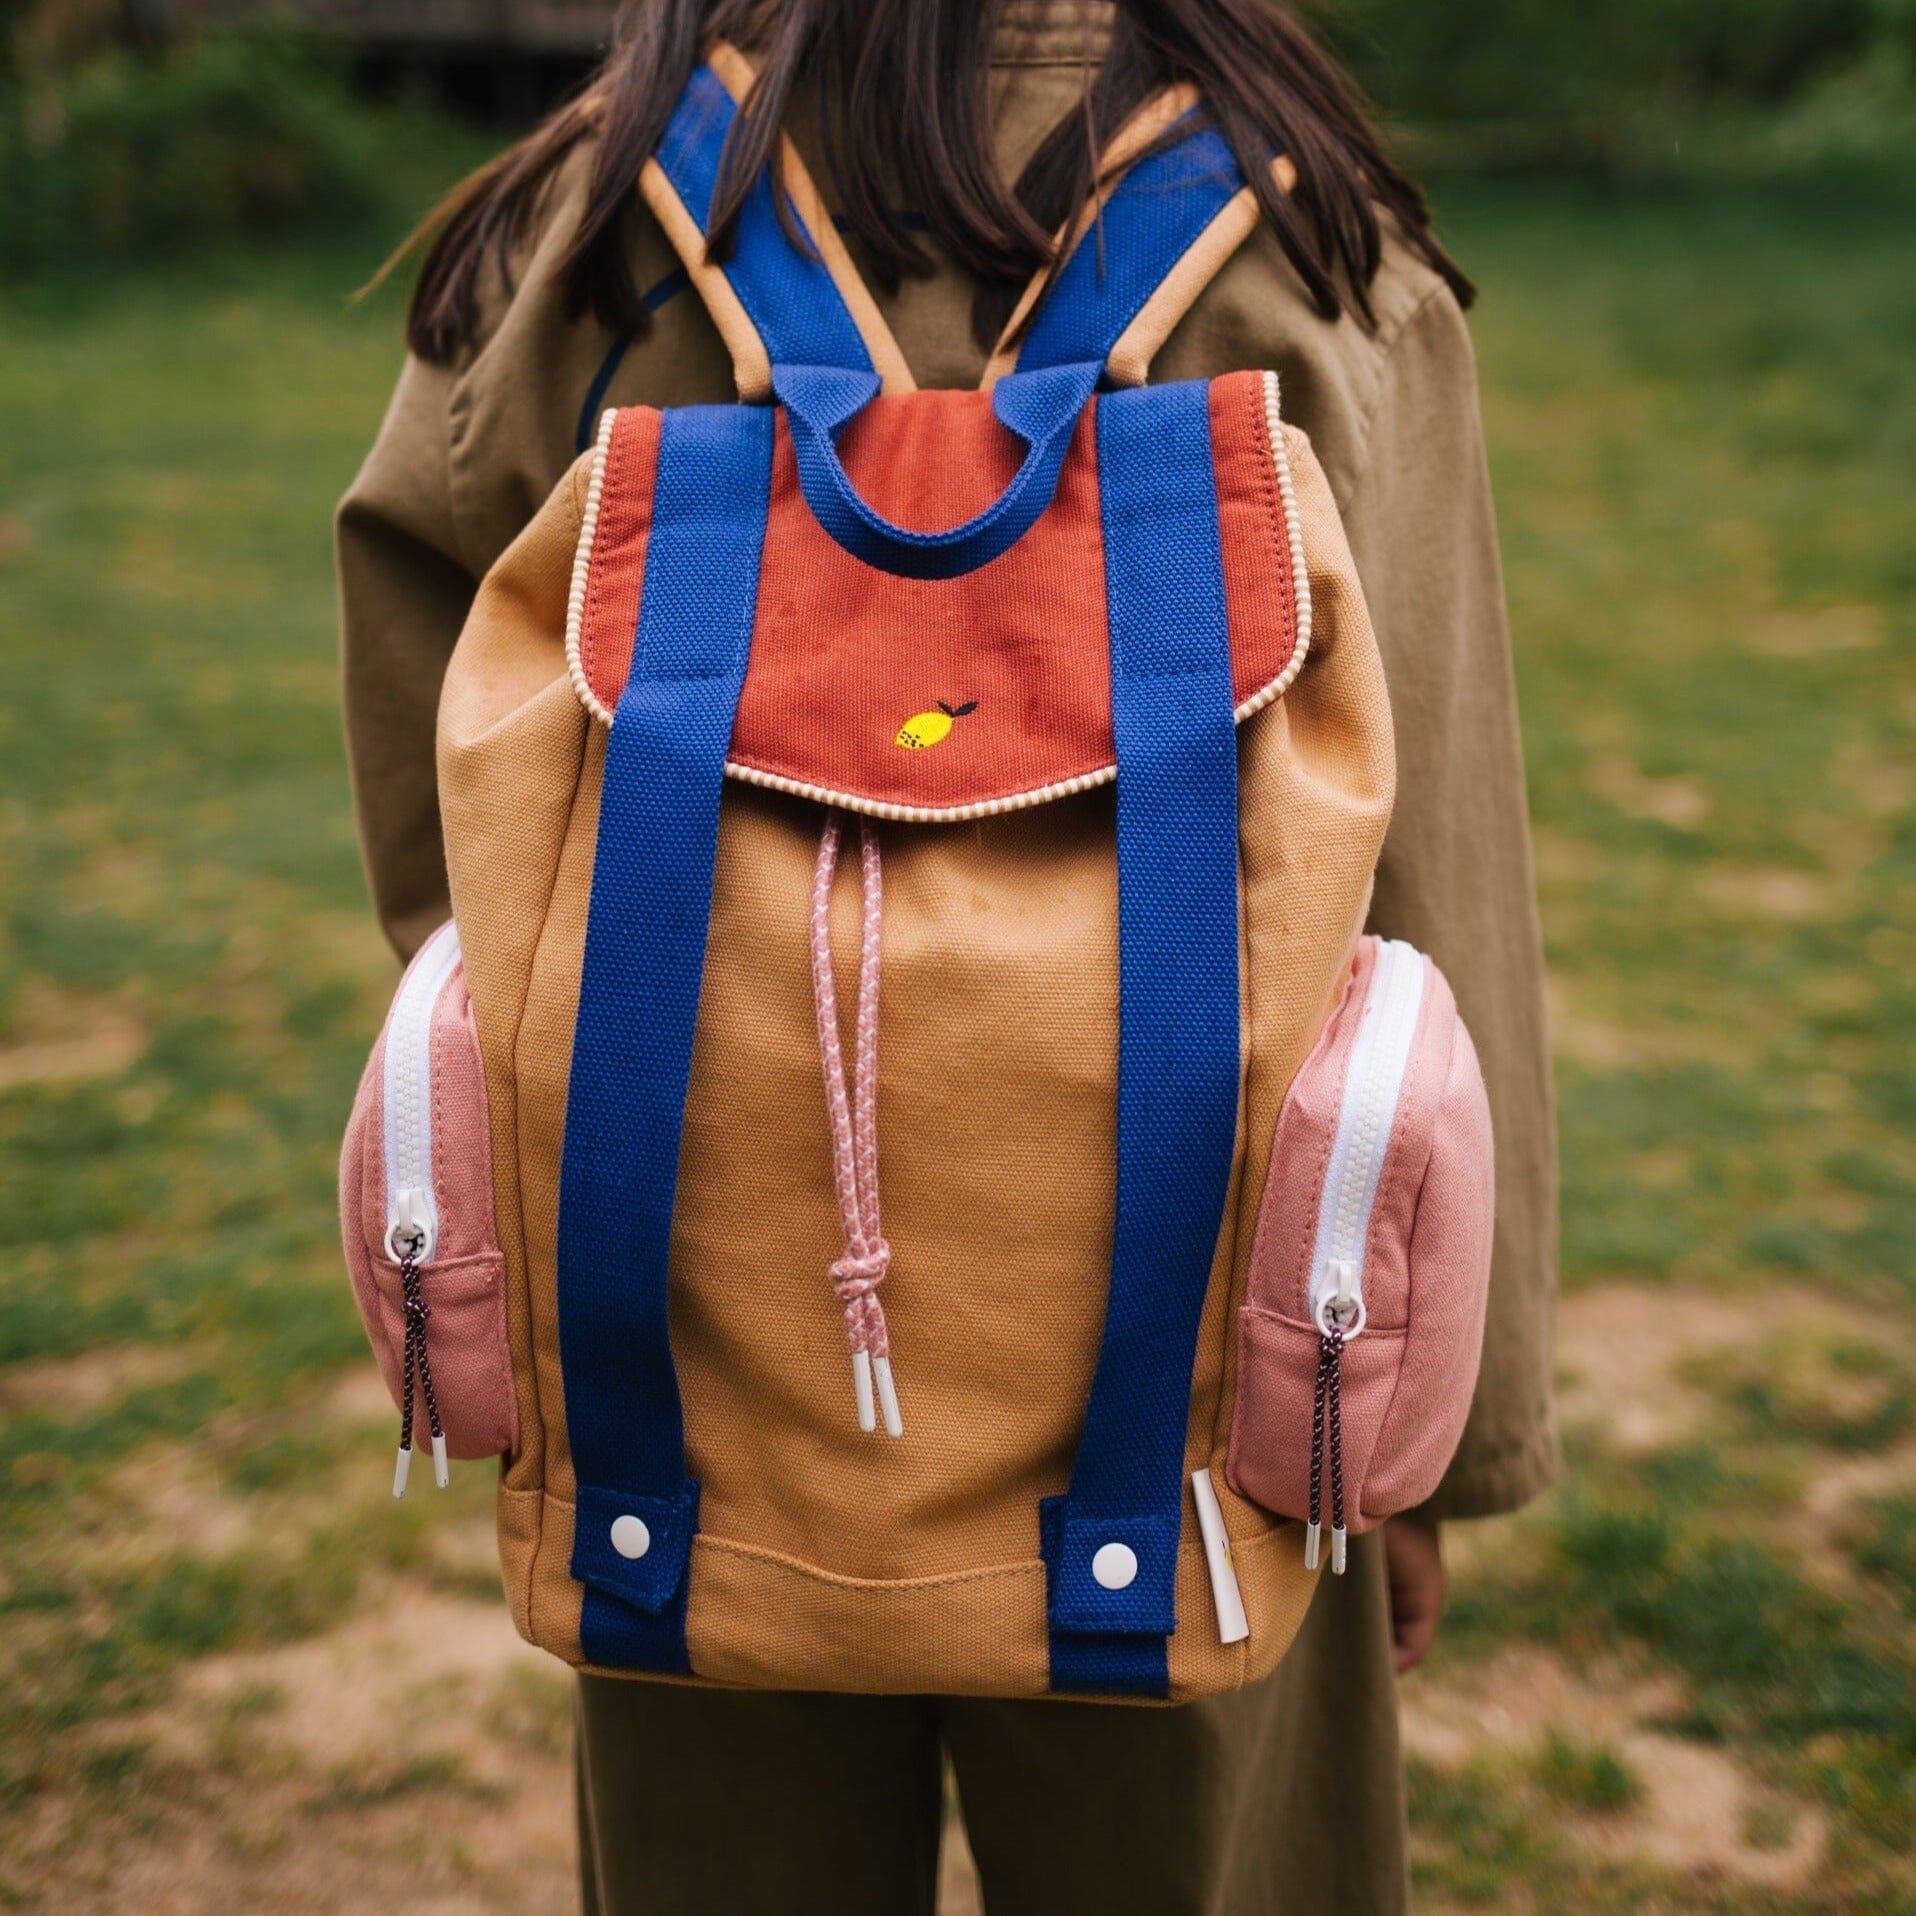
[1017,126,1243,385]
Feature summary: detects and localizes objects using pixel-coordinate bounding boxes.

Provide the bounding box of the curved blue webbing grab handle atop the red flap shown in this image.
[772,362,1102,579]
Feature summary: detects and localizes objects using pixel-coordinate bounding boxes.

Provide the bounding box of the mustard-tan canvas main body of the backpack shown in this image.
[439,352,1391,1698]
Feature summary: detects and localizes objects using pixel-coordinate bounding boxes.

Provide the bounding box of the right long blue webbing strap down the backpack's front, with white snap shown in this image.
[1040,381,1240,1696]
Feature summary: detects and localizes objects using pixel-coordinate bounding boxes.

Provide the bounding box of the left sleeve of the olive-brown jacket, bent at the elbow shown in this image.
[335,360,477,958]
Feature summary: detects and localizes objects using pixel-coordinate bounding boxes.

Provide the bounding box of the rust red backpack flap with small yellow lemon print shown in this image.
[567,374,1301,820]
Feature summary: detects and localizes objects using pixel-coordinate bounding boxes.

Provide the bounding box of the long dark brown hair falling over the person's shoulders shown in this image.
[402,0,1471,360]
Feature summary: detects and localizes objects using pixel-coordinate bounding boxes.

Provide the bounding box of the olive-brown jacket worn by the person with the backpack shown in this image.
[337,0,1556,1517]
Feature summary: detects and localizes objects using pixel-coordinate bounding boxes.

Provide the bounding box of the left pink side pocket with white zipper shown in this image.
[339,925,519,1489]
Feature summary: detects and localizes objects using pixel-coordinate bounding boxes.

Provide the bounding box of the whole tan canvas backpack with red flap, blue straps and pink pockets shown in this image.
[341,48,1493,1699]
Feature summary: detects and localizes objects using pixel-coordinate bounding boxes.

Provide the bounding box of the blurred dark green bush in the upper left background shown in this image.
[0,25,479,270]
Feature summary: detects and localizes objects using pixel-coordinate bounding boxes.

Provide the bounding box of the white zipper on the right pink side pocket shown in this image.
[1311,939,1429,1337]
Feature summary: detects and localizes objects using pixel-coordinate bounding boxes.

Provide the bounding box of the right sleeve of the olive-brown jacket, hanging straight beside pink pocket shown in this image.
[1345,287,1558,1517]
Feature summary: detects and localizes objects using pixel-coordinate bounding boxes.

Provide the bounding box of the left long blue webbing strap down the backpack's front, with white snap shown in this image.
[559,406,772,1673]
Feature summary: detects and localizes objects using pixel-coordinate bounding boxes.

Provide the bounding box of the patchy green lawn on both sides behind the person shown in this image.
[0,186,1916,1910]
